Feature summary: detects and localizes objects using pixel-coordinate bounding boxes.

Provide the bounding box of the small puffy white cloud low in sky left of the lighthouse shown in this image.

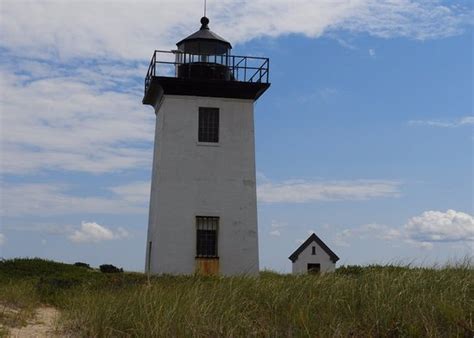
[69,222,128,243]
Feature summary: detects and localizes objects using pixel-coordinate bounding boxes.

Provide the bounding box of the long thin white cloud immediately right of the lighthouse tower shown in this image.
[257,180,400,203]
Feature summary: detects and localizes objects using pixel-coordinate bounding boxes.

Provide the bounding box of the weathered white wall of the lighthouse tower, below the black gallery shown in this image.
[146,95,259,275]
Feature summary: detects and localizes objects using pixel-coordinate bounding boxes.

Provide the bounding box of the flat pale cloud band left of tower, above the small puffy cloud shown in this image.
[1,182,149,217]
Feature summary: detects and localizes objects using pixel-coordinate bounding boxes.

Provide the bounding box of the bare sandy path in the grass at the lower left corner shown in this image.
[9,307,61,338]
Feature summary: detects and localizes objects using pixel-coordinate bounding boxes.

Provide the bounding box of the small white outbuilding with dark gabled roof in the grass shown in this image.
[288,233,339,274]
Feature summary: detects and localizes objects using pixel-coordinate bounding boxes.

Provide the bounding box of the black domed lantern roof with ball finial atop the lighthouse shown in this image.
[176,16,232,55]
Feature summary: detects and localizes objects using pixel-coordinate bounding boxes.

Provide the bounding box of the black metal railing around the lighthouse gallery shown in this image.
[145,50,270,95]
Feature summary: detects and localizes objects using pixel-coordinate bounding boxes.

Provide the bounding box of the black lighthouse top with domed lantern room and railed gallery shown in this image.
[143,17,270,108]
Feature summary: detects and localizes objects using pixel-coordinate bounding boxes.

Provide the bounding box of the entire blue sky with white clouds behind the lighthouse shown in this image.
[0,0,474,272]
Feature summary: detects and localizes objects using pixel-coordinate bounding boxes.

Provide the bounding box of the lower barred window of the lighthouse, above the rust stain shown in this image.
[196,216,219,258]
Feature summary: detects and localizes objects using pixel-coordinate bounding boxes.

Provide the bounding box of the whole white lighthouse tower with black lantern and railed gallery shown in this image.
[142,17,270,275]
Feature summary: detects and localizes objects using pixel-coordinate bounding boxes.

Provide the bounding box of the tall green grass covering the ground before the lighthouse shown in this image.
[0,259,474,337]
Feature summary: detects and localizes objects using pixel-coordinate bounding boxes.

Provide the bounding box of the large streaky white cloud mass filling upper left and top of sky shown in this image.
[0,0,472,174]
